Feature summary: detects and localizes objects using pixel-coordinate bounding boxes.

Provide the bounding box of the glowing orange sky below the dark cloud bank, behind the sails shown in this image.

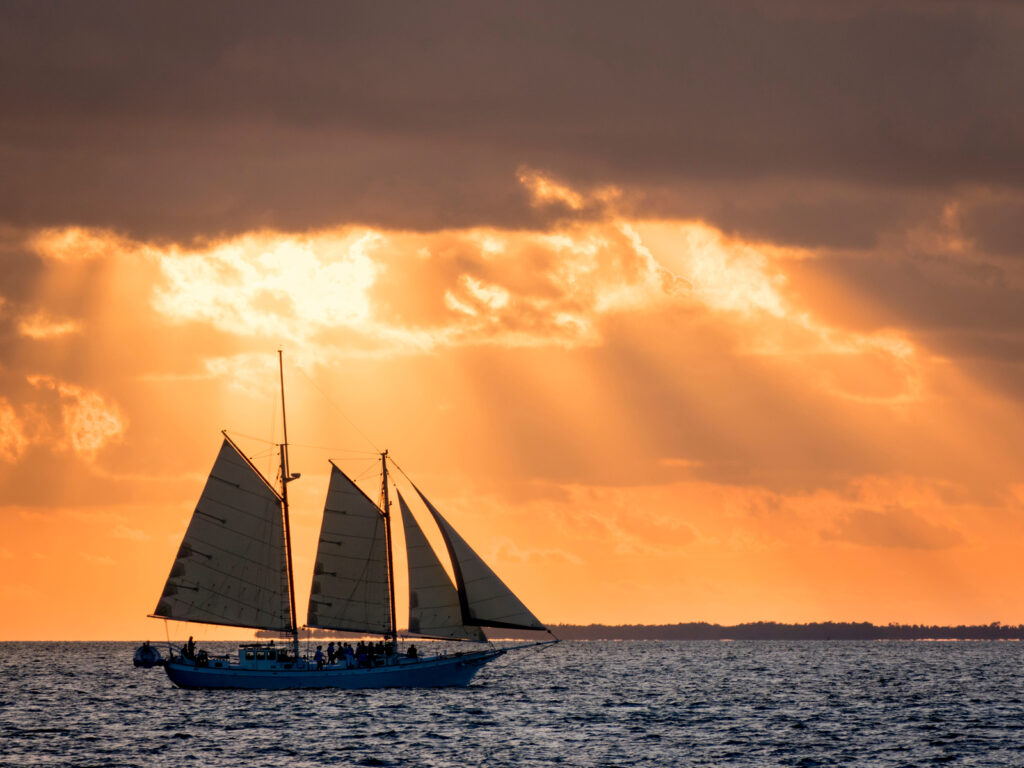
[0,172,1024,639]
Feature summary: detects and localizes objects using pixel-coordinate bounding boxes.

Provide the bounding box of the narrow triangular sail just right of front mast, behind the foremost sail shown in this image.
[398,492,487,643]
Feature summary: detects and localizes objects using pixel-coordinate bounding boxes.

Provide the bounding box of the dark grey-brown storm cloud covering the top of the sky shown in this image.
[0,0,1024,244]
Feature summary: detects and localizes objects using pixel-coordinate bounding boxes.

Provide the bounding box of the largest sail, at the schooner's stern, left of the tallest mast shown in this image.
[154,439,292,631]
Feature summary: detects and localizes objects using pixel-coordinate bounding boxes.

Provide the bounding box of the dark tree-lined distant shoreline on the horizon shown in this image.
[249,622,1024,640]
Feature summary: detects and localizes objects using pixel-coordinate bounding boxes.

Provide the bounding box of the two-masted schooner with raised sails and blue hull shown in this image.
[151,352,558,689]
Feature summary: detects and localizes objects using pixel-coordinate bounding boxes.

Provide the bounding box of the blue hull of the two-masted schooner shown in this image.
[164,648,505,690]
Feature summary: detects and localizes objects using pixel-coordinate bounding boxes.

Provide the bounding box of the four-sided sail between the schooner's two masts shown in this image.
[306,464,391,634]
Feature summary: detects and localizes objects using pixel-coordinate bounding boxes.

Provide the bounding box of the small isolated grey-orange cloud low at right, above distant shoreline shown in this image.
[821,507,964,550]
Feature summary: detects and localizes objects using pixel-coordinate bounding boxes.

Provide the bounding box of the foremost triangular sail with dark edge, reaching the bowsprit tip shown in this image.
[413,485,547,630]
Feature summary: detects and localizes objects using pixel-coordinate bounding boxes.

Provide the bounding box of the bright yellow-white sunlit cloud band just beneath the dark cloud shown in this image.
[23,170,937,407]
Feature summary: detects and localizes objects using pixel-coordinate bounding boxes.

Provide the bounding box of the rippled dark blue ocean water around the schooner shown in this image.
[0,641,1024,768]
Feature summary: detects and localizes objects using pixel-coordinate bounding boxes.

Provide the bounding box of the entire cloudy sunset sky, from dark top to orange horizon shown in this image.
[0,0,1024,640]
